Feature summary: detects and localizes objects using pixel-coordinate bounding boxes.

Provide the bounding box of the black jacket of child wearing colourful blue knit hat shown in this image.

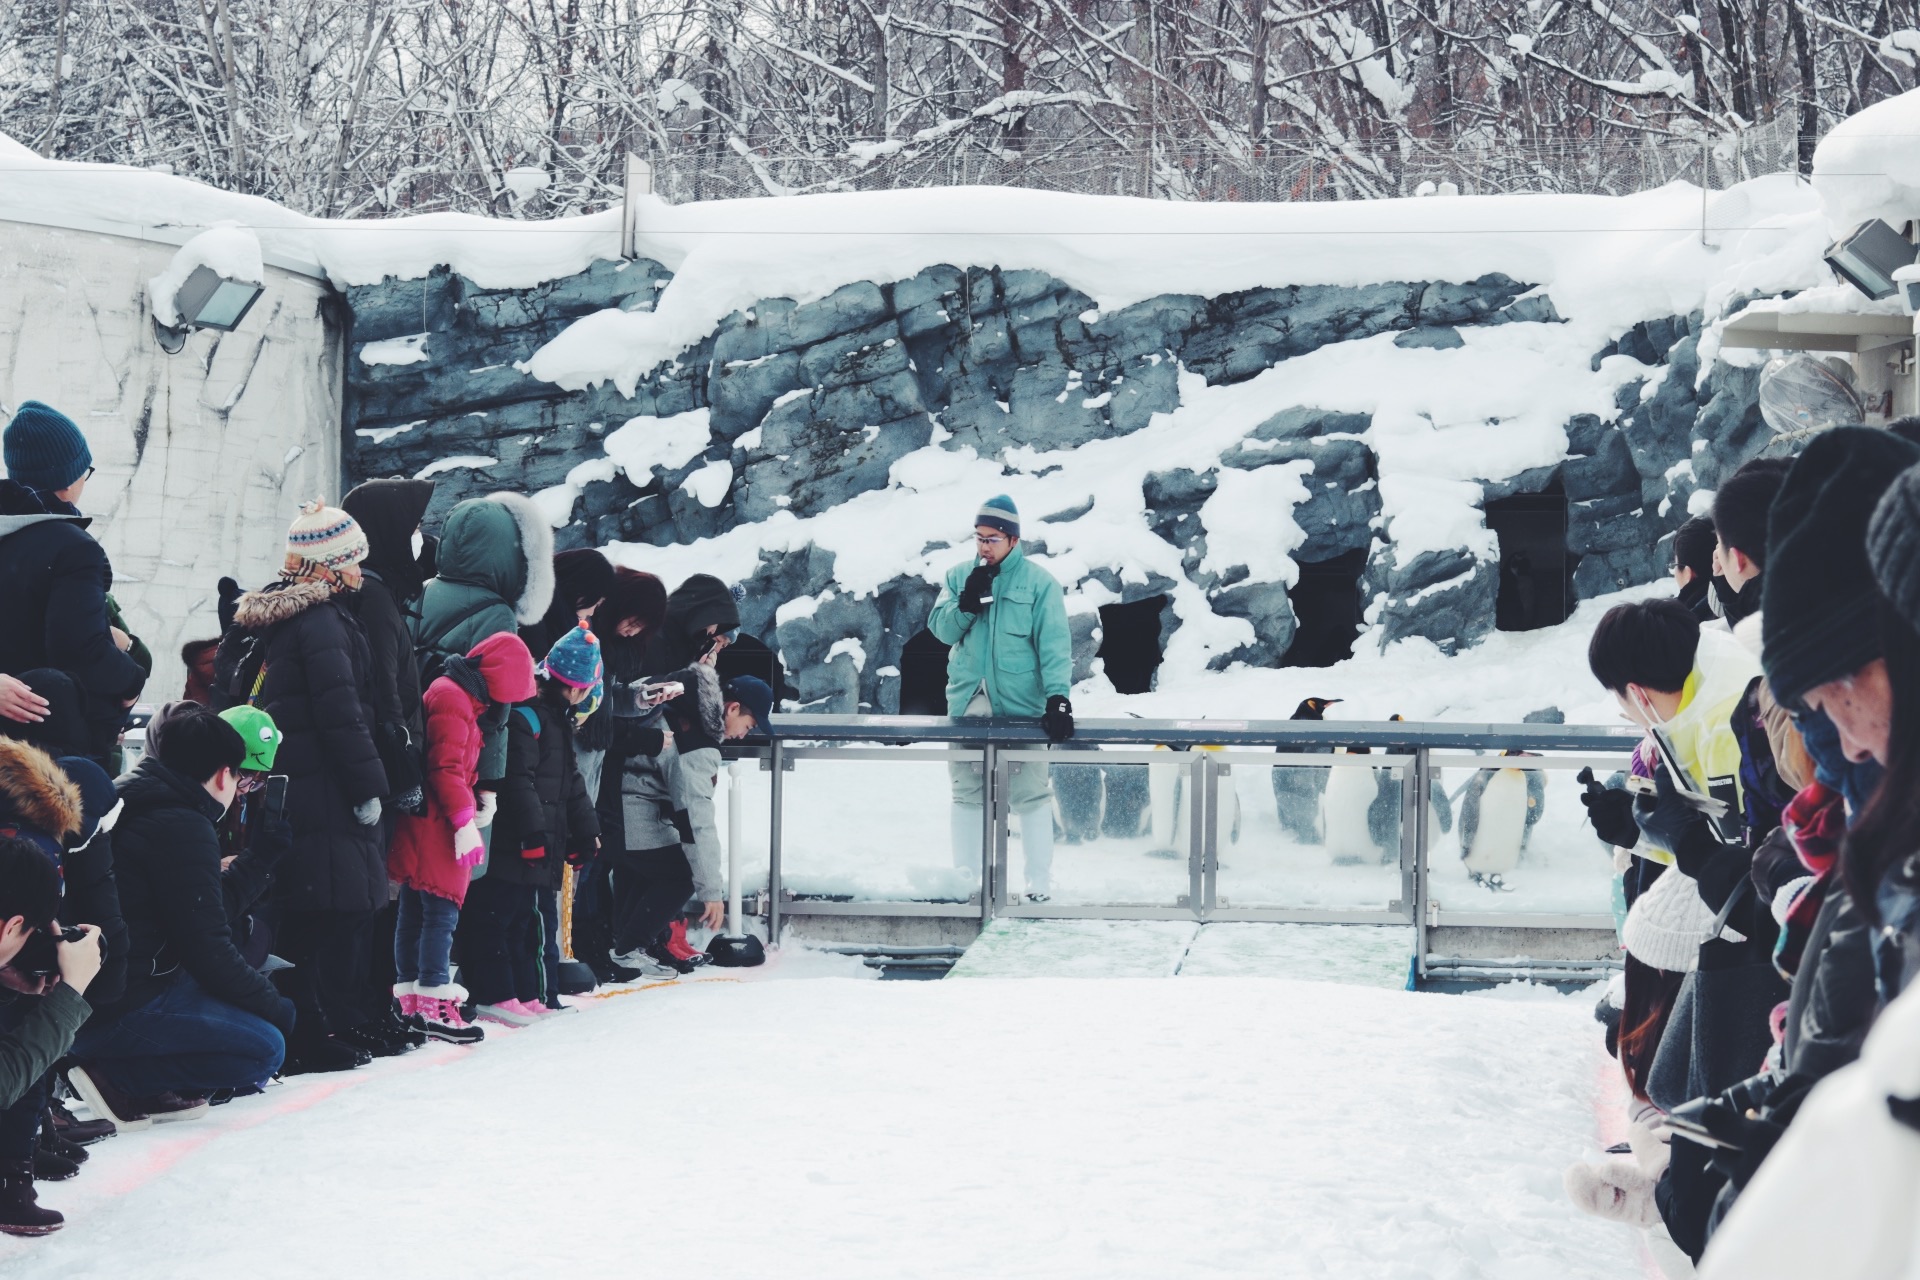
[488,681,599,889]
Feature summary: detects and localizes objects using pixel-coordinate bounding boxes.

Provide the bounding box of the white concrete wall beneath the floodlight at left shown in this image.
[0,221,344,704]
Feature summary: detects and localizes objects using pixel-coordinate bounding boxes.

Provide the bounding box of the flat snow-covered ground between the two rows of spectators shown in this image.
[0,967,1649,1280]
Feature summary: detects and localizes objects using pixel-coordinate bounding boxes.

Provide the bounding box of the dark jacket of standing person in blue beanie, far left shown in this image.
[0,480,146,702]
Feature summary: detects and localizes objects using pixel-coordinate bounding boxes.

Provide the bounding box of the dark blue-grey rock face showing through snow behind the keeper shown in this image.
[346,249,1764,710]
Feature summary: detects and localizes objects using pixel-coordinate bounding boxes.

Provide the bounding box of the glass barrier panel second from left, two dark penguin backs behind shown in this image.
[1006,750,1192,908]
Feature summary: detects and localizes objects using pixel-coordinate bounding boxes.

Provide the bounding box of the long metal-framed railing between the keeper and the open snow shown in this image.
[728,716,1640,977]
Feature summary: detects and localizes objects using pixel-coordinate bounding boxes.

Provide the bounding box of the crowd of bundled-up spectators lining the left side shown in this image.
[0,401,774,1236]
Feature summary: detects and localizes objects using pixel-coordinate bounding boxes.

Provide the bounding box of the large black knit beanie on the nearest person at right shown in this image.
[1761,426,1920,706]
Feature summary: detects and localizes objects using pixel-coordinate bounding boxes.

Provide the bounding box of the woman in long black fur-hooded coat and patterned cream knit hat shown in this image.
[215,503,388,1071]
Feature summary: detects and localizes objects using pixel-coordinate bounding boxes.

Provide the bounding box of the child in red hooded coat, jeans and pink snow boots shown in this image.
[386,631,534,1044]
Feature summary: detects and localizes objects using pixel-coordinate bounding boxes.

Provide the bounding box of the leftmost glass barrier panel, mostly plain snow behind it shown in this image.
[780,750,983,904]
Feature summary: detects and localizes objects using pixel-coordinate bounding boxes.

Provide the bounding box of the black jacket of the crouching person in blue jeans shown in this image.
[102,756,286,1031]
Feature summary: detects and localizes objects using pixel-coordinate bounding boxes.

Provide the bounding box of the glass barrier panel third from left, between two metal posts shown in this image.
[1213,754,1407,912]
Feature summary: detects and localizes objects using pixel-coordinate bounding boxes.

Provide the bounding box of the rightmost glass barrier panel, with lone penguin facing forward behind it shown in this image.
[1427,756,1626,919]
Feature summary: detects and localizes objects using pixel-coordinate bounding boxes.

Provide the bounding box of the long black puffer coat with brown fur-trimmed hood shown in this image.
[215,581,388,912]
